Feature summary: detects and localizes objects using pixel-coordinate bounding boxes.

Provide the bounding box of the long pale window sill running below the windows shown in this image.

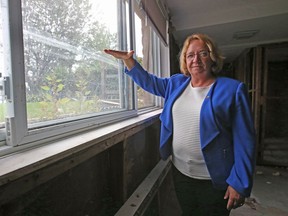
[0,109,162,186]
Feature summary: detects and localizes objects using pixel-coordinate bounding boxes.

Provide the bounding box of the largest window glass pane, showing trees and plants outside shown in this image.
[22,0,131,126]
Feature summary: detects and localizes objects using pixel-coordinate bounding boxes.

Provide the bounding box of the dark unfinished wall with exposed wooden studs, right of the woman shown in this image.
[234,43,288,166]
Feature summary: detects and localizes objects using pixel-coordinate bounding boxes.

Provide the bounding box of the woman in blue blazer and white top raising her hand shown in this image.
[105,34,255,216]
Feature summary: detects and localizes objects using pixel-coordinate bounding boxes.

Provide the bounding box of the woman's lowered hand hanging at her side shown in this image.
[224,185,245,211]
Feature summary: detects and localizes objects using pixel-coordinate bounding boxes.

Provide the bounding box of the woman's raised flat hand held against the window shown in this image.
[104,49,135,70]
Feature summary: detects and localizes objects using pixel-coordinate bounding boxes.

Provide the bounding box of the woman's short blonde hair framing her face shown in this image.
[180,33,224,76]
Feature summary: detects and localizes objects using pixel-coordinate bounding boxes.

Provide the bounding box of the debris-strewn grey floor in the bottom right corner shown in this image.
[230,166,288,216]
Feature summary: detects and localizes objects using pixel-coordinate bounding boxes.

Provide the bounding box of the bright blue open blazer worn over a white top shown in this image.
[125,62,256,197]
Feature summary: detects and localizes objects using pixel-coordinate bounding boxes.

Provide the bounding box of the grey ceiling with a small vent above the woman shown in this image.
[162,0,288,63]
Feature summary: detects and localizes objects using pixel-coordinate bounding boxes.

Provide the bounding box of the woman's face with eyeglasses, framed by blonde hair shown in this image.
[185,40,213,79]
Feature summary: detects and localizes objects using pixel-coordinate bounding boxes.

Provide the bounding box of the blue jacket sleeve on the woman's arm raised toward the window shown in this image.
[125,60,169,98]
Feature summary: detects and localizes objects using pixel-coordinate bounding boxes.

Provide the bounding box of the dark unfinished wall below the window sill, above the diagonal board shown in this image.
[0,121,159,216]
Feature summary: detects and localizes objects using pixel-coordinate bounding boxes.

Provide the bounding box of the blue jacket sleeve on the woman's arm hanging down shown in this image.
[227,83,256,197]
